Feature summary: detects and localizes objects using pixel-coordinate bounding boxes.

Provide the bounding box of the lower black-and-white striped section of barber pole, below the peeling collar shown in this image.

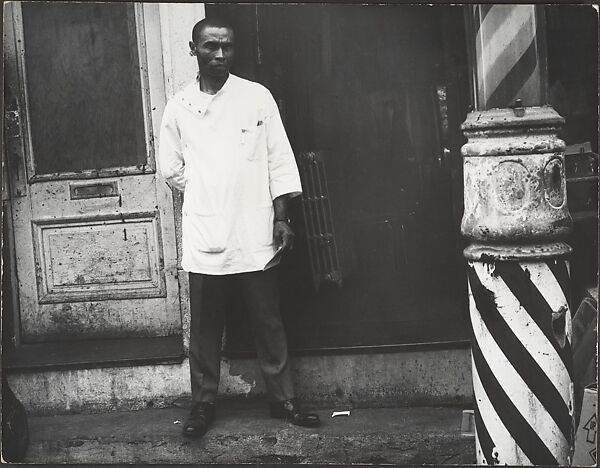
[468,259,574,465]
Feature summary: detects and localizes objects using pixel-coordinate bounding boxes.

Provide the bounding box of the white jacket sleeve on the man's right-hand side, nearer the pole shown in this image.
[265,92,302,200]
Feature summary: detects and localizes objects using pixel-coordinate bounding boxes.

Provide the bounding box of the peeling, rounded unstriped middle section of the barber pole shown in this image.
[461,107,572,243]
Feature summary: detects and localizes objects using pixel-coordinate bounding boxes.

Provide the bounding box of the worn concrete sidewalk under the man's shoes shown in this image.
[25,400,475,465]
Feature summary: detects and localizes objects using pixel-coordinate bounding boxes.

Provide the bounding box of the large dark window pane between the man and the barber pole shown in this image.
[274,5,468,348]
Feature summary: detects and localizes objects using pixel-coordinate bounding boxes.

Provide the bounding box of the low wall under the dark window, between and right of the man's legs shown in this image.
[220,349,472,407]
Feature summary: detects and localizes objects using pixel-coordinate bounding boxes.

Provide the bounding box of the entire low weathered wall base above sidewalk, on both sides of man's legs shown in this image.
[9,349,472,414]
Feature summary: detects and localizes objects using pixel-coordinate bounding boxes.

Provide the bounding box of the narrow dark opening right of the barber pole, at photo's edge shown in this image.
[544,5,599,311]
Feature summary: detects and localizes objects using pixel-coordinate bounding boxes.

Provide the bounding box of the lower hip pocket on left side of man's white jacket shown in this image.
[182,210,228,253]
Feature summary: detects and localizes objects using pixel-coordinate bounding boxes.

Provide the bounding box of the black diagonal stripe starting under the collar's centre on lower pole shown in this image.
[496,262,573,380]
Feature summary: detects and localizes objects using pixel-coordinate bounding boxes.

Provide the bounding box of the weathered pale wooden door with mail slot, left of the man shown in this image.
[5,2,181,343]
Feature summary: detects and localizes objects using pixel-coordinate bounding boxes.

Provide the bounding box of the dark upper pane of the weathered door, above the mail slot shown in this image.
[22,2,146,174]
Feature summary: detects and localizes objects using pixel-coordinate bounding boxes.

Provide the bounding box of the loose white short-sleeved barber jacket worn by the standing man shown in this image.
[158,74,302,275]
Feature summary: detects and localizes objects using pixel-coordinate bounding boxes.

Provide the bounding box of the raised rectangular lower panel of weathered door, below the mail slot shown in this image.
[33,213,165,303]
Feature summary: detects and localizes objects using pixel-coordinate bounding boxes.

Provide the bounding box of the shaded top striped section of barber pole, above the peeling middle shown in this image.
[472,4,546,109]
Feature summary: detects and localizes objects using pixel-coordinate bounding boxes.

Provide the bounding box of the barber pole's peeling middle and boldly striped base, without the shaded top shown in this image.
[461,107,573,465]
